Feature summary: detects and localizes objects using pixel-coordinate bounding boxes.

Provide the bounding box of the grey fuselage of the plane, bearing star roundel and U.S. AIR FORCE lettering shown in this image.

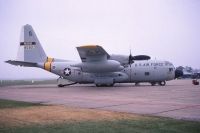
[41,60,175,84]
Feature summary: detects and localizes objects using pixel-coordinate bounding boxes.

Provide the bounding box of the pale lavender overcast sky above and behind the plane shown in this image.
[0,0,200,79]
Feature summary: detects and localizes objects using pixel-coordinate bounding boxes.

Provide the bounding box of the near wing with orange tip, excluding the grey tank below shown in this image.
[77,45,110,62]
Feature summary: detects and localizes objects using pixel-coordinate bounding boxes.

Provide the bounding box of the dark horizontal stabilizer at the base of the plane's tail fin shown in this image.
[5,60,37,67]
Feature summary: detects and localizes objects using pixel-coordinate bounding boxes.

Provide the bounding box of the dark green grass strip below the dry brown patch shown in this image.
[0,118,200,133]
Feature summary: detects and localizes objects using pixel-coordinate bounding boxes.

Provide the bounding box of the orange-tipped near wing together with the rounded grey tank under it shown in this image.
[72,45,123,73]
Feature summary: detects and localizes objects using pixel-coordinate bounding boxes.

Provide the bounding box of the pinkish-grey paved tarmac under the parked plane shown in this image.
[0,80,200,121]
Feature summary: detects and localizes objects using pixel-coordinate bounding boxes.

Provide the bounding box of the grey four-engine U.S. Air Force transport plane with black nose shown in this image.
[6,24,182,87]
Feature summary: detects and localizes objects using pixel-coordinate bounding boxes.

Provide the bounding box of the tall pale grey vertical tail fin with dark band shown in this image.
[17,24,47,63]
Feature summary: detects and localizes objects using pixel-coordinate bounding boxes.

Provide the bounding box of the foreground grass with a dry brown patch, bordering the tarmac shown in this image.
[0,100,200,133]
